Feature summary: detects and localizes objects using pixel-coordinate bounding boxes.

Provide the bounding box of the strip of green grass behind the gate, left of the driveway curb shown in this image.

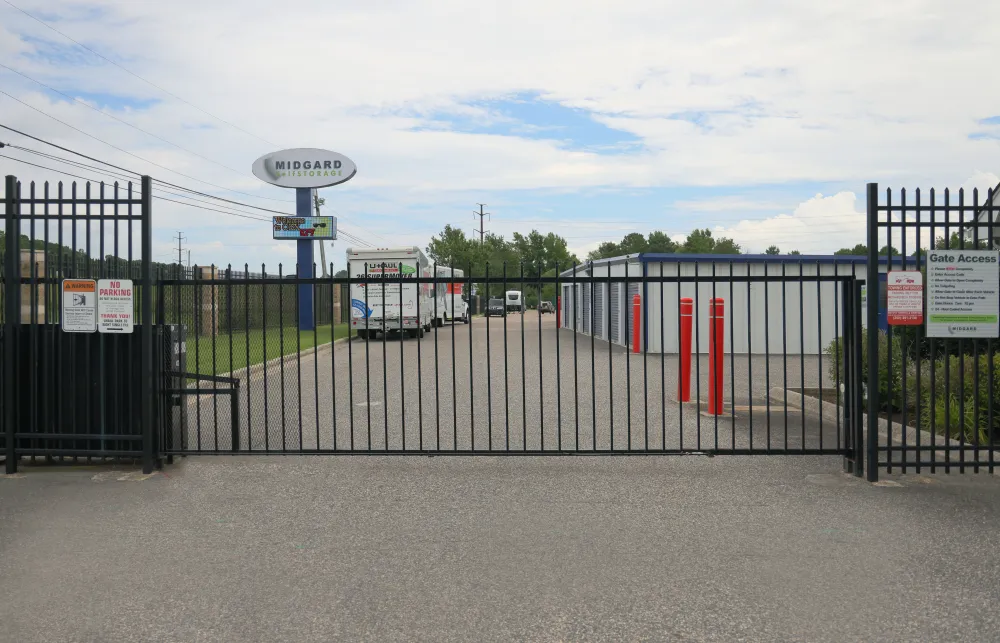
[187,324,349,375]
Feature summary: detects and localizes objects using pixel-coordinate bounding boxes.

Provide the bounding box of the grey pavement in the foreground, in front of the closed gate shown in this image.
[0,456,1000,643]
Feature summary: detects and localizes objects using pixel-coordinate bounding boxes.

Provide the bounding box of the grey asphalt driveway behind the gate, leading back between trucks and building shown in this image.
[178,312,842,452]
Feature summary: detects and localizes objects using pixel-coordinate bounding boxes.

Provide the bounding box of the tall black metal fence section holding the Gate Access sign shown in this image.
[862,183,1000,480]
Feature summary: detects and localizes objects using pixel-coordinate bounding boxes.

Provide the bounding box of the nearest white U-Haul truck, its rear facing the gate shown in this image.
[347,246,434,339]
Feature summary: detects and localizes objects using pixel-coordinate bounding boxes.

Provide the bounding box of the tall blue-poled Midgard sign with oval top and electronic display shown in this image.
[253,148,358,331]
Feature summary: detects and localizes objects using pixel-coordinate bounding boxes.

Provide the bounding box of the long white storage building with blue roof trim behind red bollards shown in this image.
[560,253,900,355]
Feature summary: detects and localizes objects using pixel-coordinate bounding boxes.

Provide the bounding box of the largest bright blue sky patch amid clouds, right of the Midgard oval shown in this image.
[417,93,642,151]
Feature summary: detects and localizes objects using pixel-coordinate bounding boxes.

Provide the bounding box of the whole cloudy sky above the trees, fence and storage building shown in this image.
[0,0,1000,266]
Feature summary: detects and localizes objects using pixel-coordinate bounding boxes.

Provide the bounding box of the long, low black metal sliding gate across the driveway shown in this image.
[156,261,862,474]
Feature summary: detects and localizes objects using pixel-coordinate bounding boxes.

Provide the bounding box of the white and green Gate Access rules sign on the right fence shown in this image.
[927,250,1000,338]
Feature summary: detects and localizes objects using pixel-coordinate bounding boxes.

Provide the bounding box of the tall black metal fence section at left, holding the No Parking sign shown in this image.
[0,176,154,473]
